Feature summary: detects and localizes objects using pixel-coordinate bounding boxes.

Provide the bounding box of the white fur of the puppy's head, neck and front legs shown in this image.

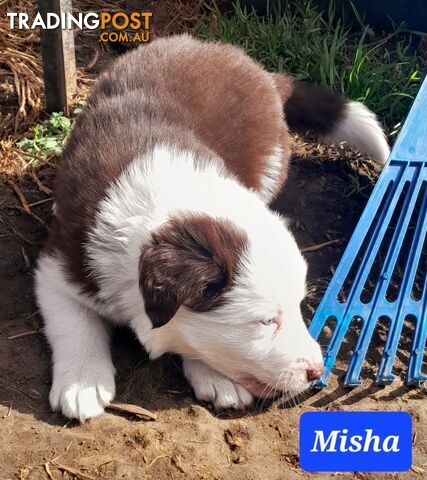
[36,146,322,420]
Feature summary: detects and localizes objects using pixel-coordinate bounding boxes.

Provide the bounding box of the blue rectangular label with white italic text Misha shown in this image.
[299,412,412,472]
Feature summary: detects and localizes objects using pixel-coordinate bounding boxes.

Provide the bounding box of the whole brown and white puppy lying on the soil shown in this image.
[36,36,388,421]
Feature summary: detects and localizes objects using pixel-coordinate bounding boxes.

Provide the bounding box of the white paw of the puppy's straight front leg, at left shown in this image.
[49,370,116,423]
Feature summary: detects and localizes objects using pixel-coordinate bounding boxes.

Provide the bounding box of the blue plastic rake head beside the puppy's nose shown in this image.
[310,79,427,388]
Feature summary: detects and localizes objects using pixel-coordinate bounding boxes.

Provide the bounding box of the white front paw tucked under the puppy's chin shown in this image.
[183,359,253,410]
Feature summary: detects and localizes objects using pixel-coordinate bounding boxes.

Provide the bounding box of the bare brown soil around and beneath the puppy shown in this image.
[0,141,427,480]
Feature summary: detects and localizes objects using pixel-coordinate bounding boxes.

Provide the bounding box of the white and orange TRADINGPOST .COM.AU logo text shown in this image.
[6,11,153,43]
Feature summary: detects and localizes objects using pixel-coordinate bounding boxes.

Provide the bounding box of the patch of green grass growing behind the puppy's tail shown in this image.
[196,0,421,134]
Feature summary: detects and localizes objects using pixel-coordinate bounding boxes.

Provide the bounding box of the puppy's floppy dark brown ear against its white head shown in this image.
[139,215,247,327]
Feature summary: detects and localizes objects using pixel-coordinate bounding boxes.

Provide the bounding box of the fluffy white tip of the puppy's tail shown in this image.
[322,101,390,165]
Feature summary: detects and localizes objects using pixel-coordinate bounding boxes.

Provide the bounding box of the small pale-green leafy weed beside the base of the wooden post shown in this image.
[17,112,71,164]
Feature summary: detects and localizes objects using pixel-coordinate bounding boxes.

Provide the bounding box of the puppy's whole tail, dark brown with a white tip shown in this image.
[275,74,390,164]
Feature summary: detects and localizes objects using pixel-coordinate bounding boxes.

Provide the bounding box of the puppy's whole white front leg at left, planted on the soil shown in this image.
[36,256,115,422]
